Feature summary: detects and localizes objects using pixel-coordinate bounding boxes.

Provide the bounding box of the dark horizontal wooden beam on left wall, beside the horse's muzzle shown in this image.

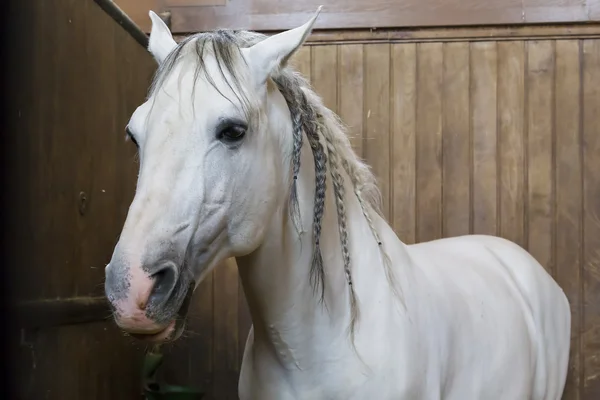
[16,297,111,329]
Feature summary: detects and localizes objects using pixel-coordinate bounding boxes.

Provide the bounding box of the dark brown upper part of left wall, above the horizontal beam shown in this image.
[7,0,155,300]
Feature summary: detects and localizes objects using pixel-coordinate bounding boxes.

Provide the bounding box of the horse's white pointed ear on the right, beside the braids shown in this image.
[242,6,323,84]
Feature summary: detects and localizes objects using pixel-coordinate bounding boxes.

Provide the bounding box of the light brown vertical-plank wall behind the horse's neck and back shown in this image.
[295,27,600,400]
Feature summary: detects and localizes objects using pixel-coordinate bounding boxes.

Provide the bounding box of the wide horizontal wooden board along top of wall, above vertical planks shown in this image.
[130,0,600,32]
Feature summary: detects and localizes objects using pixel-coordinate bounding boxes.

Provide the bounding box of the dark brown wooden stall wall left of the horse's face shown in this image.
[2,0,155,400]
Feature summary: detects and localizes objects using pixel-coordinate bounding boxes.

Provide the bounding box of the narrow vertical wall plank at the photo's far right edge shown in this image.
[581,39,600,399]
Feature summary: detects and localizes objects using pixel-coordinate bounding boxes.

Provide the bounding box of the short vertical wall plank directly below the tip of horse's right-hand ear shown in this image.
[311,45,338,112]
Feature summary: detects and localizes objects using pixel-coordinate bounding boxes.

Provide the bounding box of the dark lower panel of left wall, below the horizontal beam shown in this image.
[12,322,145,400]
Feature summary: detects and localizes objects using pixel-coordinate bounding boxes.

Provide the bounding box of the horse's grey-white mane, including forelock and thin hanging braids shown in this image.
[149,29,396,337]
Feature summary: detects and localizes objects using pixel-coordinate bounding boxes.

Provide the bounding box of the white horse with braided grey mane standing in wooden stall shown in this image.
[106,7,571,400]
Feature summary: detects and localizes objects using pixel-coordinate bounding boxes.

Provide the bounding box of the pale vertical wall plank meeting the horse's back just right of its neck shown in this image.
[416,43,444,242]
